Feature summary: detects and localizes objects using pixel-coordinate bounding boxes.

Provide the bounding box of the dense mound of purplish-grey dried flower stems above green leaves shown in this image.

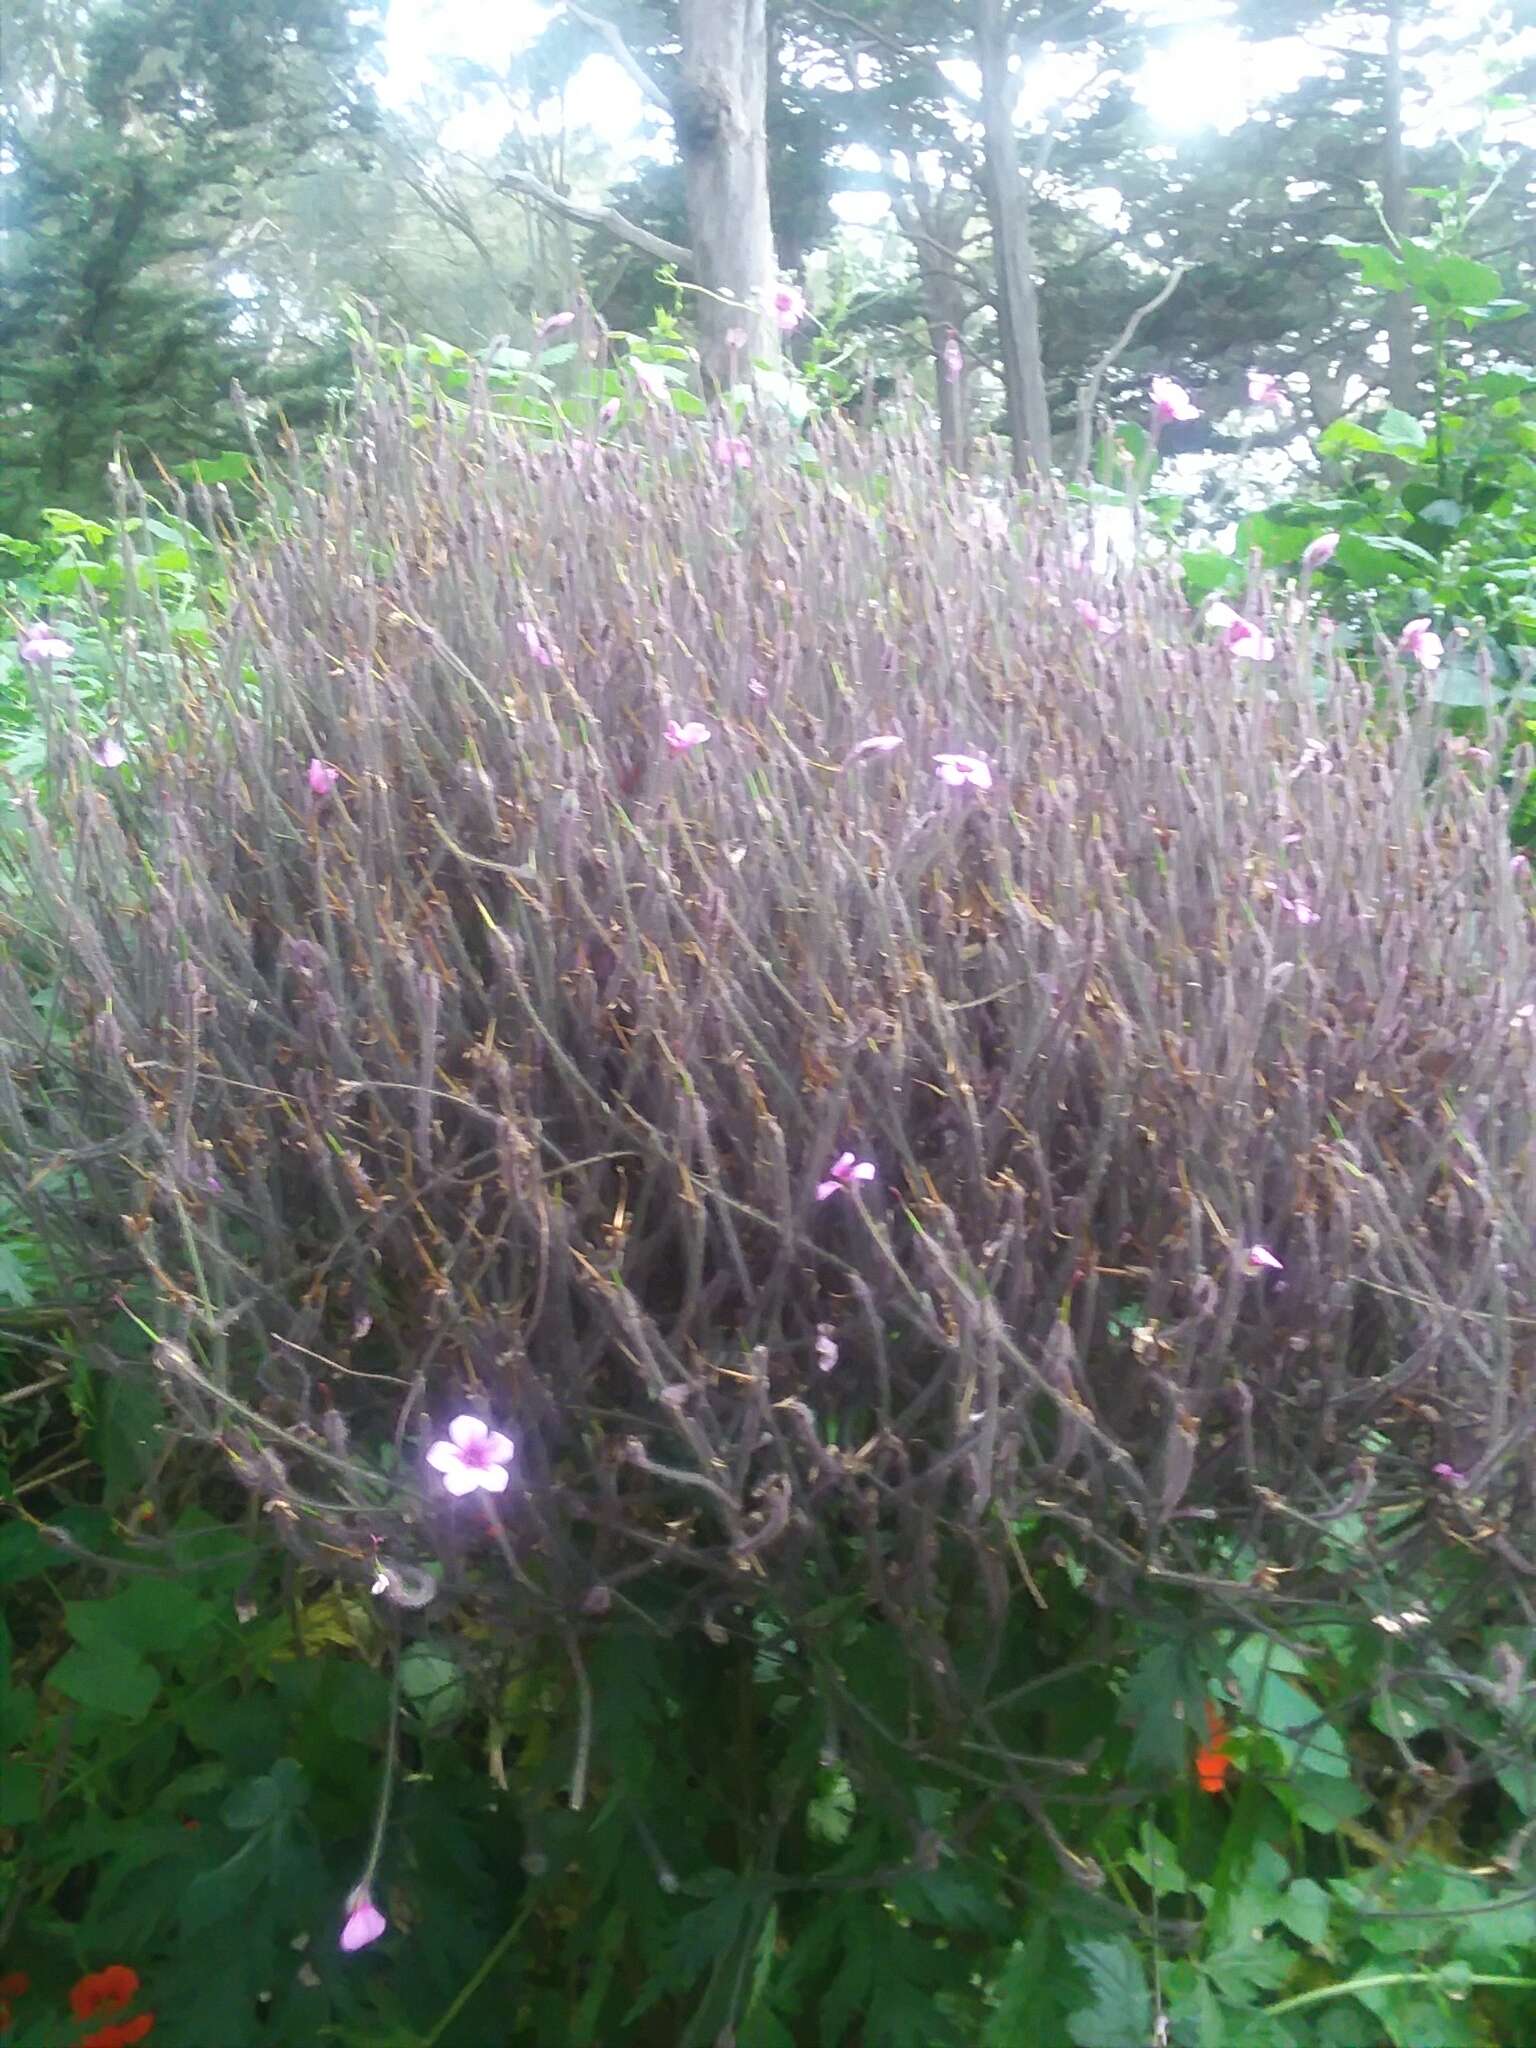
[0,381,1536,1810]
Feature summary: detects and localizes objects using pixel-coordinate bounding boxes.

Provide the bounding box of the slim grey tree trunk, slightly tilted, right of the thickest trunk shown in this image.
[975,0,1051,481]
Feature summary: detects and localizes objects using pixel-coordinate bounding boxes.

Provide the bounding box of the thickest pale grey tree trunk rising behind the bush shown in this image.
[672,0,778,385]
